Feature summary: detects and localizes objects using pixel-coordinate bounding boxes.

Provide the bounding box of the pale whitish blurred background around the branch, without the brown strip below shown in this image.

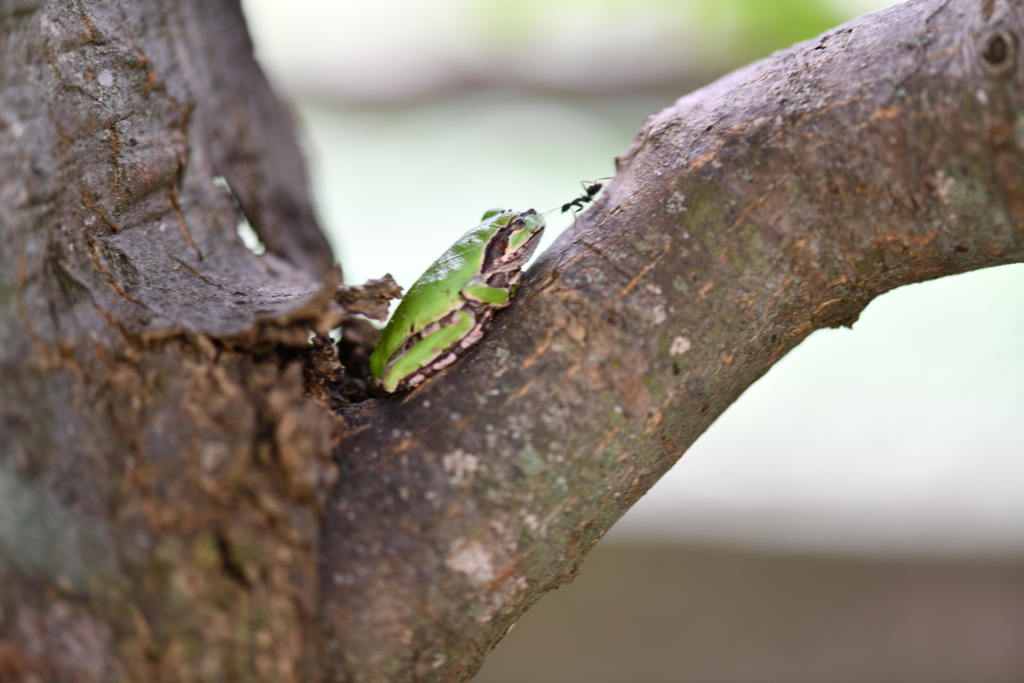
[235,0,1024,681]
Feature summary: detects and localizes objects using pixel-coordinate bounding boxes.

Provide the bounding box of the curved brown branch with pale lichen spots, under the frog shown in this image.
[322,0,1024,681]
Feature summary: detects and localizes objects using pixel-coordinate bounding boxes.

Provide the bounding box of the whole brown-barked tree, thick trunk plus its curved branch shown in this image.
[0,0,1024,682]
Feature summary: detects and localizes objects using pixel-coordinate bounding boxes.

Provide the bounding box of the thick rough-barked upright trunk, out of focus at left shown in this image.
[0,0,334,681]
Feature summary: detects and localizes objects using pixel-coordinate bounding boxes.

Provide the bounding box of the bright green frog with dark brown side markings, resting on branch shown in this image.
[370,209,544,392]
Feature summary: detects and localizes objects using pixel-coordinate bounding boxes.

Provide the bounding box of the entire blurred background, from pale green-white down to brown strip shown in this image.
[237,0,1024,683]
